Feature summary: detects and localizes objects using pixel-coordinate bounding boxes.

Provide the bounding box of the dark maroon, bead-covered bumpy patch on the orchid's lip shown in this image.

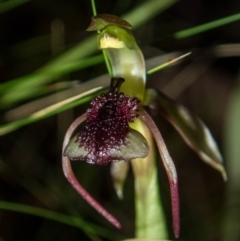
[77,92,139,164]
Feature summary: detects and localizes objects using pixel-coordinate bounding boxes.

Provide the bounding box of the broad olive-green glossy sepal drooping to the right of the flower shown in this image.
[146,89,227,181]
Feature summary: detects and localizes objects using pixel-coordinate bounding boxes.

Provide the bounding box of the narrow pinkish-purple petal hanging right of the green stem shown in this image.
[139,109,180,238]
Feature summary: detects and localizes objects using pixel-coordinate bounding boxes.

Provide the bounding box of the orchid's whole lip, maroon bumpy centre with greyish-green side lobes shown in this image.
[64,78,148,165]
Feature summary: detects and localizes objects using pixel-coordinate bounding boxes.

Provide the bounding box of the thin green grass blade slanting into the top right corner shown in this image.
[173,13,240,39]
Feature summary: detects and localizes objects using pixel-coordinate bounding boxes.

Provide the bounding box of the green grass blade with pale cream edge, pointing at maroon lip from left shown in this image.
[0,87,103,136]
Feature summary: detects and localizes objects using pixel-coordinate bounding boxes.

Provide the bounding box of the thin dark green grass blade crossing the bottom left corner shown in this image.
[0,201,123,240]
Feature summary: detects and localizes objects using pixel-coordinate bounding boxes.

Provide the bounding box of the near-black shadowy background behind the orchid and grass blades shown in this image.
[0,0,240,241]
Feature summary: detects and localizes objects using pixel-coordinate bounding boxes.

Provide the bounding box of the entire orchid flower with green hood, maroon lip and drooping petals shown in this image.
[62,14,227,238]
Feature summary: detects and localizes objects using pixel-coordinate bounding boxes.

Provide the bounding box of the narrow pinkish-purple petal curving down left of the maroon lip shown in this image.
[62,114,121,228]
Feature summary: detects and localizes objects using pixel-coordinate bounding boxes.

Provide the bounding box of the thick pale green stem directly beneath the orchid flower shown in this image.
[131,120,168,239]
